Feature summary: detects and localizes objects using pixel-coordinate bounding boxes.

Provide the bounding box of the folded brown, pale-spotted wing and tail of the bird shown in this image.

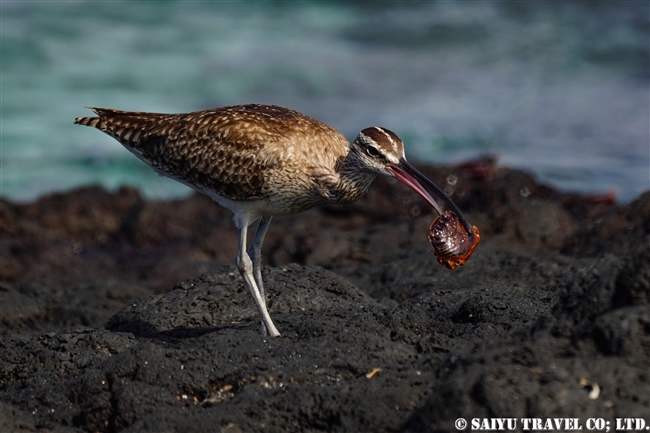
[75,106,299,200]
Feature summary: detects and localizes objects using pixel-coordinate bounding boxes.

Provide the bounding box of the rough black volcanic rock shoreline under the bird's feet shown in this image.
[0,163,650,432]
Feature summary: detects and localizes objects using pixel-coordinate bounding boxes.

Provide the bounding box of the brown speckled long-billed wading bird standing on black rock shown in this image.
[75,104,473,336]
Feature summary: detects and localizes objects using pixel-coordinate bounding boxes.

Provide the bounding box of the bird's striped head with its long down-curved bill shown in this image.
[351,126,474,239]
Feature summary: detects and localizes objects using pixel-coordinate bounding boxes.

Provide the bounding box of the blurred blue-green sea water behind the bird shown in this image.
[0,0,650,202]
